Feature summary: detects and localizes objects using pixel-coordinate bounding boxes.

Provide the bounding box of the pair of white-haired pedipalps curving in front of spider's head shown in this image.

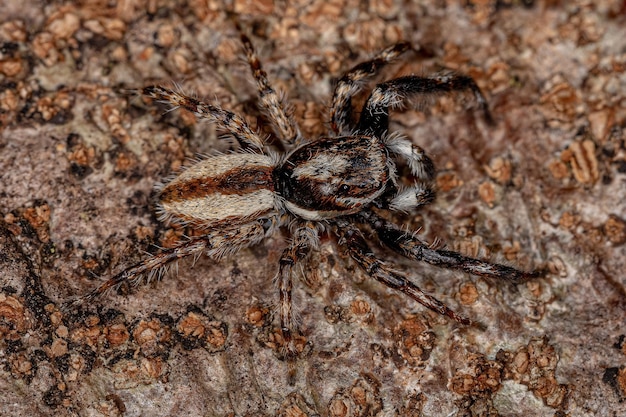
[384,135,435,212]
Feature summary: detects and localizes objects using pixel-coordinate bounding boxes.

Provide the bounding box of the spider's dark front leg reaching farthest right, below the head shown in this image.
[358,211,545,283]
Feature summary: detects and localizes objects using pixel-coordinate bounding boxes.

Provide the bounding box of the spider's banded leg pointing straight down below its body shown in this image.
[276,223,319,359]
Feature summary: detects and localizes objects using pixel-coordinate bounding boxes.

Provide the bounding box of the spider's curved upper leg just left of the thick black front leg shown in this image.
[330,42,411,135]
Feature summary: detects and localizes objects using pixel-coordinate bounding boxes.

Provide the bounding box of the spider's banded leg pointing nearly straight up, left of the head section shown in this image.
[241,33,301,145]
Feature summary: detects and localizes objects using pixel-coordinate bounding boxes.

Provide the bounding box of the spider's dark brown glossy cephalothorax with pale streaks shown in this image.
[274,136,389,220]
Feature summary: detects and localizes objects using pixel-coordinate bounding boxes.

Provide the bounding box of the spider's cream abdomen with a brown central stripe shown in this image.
[157,153,276,227]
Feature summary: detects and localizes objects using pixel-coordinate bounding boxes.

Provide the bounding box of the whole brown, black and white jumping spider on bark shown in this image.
[77,35,541,356]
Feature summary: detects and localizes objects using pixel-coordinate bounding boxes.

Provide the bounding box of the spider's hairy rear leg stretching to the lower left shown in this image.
[71,221,265,306]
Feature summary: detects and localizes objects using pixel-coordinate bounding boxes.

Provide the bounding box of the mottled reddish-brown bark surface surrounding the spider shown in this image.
[0,0,626,416]
